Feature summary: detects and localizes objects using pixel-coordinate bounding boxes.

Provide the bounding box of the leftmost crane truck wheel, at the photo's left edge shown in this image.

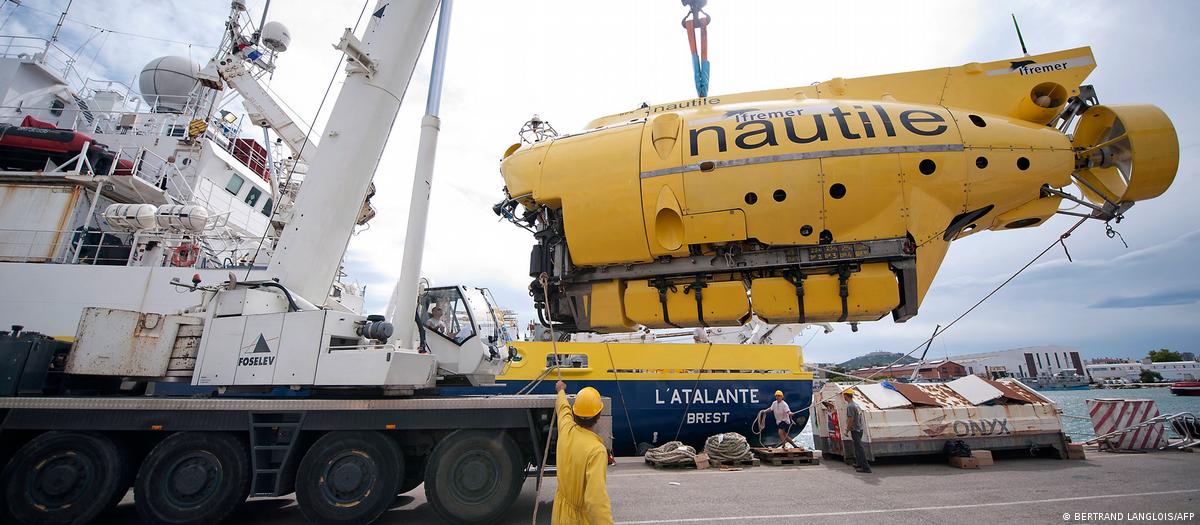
[0,432,130,524]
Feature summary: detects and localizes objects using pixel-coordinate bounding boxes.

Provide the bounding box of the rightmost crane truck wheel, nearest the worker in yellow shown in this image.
[425,430,524,523]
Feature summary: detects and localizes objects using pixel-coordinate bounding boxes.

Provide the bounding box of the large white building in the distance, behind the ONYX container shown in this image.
[952,346,1085,378]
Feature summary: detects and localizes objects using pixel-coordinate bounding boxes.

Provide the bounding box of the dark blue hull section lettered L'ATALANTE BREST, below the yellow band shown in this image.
[439,378,812,455]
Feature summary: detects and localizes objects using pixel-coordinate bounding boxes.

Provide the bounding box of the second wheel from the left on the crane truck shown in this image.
[133,432,250,525]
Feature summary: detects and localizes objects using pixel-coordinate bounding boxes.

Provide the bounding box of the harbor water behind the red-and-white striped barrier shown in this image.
[792,387,1200,448]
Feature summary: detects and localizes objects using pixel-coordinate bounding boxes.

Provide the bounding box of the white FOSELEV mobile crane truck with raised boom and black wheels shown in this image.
[0,0,600,524]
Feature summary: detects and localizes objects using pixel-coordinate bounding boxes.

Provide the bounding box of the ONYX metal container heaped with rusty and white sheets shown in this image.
[812,375,1068,460]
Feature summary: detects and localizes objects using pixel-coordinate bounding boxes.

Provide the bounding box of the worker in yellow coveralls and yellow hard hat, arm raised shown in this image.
[553,381,612,525]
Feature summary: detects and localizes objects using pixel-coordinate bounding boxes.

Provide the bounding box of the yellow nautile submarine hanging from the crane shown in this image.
[496,47,1178,332]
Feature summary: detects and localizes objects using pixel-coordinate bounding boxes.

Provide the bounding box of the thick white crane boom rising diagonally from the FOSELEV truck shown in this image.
[270,0,438,303]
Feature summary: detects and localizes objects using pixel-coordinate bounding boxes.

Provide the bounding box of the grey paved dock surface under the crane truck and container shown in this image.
[110,451,1200,525]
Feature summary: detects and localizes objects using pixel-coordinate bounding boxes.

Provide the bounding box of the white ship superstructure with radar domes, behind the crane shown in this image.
[0,1,364,336]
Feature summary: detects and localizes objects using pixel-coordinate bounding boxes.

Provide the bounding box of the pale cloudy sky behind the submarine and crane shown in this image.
[0,0,1200,362]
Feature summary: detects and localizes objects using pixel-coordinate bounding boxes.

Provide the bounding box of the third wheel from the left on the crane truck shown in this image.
[296,430,404,524]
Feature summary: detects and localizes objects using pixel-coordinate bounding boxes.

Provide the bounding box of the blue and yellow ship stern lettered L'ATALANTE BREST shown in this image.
[440,342,812,455]
